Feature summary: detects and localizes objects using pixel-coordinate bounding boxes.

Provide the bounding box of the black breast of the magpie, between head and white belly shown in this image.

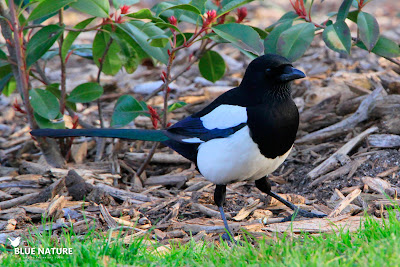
[247,97,299,158]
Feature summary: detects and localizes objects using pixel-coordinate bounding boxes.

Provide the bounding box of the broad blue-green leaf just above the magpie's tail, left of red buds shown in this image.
[111,95,147,126]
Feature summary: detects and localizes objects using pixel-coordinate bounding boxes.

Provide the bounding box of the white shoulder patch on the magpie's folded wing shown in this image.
[200,105,247,130]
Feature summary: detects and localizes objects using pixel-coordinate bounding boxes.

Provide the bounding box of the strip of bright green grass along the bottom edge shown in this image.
[0,212,400,267]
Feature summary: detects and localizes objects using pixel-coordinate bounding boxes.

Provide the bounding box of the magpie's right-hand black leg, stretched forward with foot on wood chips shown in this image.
[256,177,326,222]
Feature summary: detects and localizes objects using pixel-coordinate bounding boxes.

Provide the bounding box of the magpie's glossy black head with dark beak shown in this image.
[242,54,306,96]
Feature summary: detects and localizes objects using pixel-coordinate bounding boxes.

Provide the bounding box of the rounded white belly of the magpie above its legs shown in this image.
[197,126,291,184]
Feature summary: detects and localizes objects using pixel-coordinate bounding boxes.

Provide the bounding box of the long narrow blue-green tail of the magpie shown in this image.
[31,129,169,142]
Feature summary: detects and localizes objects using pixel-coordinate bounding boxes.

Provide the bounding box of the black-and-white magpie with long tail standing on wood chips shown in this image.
[31,54,325,240]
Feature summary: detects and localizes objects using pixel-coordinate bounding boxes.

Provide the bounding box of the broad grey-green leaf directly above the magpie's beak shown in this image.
[276,23,315,61]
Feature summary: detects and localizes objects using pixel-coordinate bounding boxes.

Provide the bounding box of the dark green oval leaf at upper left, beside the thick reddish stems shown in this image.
[26,25,63,67]
